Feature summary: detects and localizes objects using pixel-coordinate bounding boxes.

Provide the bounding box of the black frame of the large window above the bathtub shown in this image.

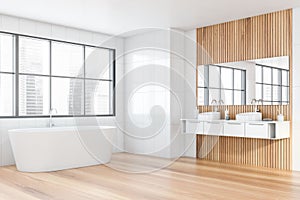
[0,31,116,119]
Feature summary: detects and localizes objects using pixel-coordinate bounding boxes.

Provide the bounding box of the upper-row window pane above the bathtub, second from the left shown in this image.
[19,37,50,75]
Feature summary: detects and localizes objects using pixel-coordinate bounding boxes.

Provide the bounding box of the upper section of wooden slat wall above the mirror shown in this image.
[197,10,292,65]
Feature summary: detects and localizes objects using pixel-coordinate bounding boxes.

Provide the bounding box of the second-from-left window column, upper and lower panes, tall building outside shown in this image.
[18,37,50,116]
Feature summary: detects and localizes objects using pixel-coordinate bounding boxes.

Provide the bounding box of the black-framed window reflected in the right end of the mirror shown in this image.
[256,64,289,105]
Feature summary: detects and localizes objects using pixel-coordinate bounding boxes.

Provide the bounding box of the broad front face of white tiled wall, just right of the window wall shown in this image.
[124,30,170,157]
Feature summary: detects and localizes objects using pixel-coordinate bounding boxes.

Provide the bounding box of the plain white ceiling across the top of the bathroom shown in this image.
[0,0,300,34]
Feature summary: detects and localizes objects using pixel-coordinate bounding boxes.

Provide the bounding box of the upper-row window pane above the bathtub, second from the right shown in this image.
[52,42,84,77]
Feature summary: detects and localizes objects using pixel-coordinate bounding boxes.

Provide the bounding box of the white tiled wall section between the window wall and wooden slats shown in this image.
[124,29,196,158]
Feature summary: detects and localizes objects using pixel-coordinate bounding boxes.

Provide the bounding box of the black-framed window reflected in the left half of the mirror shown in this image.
[198,65,246,105]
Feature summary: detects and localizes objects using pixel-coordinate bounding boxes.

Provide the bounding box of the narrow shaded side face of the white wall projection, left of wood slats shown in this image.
[170,29,189,158]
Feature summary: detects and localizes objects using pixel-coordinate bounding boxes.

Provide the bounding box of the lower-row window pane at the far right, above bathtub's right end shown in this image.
[85,80,113,115]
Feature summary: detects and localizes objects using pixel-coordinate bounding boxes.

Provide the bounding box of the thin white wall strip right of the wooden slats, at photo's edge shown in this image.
[292,8,300,171]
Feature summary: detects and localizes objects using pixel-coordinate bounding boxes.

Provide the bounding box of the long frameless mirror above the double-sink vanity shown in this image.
[197,56,290,105]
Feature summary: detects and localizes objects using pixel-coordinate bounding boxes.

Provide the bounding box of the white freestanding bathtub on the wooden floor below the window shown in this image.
[8,126,116,172]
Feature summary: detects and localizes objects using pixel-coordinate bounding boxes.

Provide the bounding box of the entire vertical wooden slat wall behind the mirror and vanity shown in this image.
[197,9,292,170]
